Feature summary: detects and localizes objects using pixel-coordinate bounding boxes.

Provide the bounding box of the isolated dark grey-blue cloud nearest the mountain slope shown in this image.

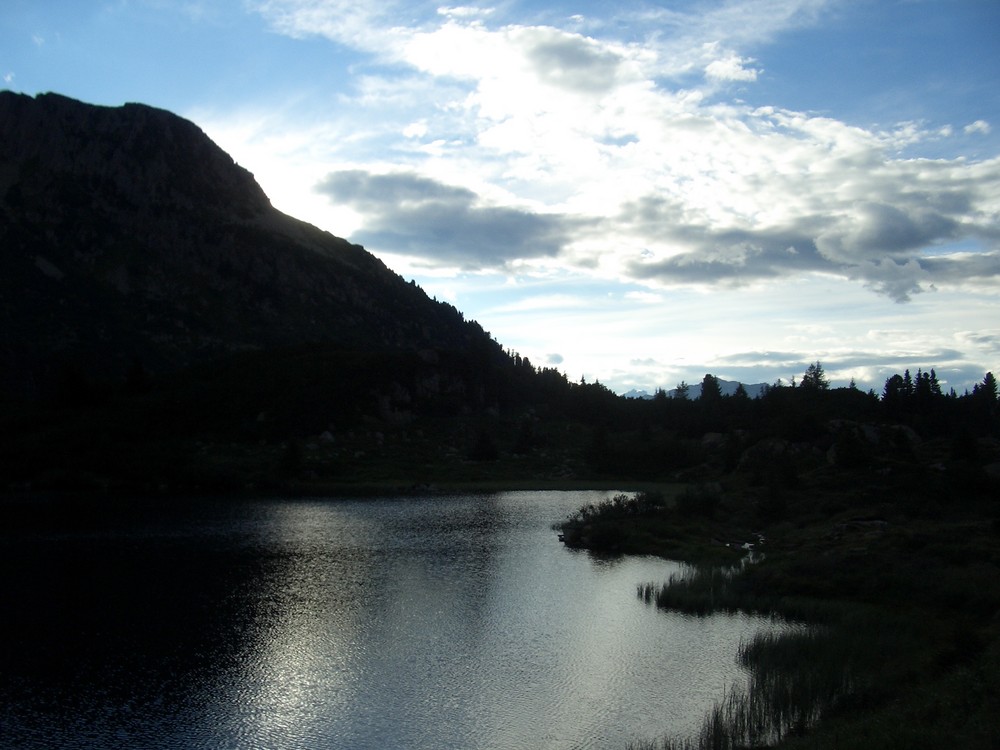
[316,170,585,270]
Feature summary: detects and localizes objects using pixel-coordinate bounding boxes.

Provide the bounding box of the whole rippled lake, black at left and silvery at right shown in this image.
[0,492,773,750]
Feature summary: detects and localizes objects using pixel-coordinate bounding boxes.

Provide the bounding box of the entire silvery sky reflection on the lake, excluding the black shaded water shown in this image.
[209,494,788,748]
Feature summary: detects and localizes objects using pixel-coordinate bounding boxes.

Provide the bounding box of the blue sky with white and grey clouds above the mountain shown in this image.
[0,0,1000,394]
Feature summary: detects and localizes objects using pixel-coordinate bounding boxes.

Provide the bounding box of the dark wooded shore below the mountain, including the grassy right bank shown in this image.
[7,354,1000,748]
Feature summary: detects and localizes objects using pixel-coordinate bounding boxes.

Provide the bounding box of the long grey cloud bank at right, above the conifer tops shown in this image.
[620,195,1000,302]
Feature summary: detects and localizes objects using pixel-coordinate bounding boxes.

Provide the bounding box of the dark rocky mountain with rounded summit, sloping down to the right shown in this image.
[0,91,499,395]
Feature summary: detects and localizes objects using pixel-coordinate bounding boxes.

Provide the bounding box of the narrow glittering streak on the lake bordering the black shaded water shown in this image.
[217,503,377,747]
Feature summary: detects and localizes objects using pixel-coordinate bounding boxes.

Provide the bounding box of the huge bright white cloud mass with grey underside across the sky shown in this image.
[258,0,1000,302]
